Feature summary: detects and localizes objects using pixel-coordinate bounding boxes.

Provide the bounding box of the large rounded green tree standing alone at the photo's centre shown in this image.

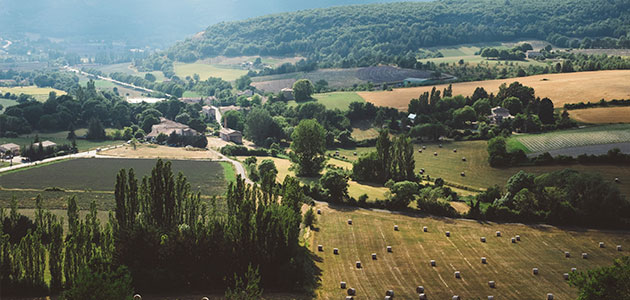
[290,119,326,176]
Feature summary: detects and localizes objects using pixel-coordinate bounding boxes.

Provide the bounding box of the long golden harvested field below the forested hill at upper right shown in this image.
[357,70,630,110]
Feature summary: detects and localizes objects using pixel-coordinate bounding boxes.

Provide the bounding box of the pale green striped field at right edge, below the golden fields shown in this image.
[510,124,630,152]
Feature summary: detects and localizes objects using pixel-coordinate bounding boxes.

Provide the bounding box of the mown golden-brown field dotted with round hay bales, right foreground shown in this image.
[309,205,630,299]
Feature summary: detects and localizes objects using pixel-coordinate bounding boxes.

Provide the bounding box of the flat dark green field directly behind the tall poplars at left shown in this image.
[0,158,225,195]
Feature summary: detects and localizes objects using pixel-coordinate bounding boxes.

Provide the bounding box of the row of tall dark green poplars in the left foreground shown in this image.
[0,160,314,299]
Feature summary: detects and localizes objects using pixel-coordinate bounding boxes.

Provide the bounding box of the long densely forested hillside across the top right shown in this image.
[168,0,630,67]
